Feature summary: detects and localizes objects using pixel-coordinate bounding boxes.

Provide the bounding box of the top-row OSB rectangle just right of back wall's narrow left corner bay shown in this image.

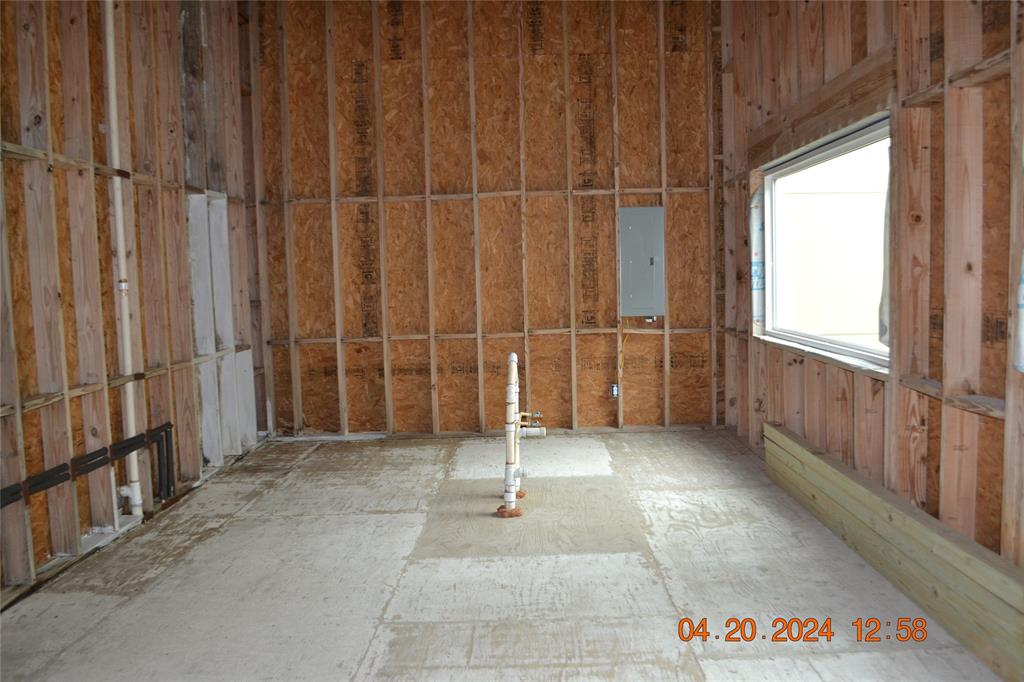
[285,1,331,198]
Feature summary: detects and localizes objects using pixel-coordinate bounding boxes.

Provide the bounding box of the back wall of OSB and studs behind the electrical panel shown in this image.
[253,2,724,433]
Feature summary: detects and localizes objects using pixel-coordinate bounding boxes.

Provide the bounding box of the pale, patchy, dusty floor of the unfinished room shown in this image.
[2,430,994,682]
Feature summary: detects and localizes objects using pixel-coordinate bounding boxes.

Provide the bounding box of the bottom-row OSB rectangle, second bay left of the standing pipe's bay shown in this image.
[391,341,433,433]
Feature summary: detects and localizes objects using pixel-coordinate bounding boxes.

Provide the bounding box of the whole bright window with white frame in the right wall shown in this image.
[755,121,889,365]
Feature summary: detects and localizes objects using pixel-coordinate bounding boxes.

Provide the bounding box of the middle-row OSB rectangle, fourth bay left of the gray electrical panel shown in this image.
[432,201,476,334]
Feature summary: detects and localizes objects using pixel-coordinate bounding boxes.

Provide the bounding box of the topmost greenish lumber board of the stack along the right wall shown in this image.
[765,424,1024,612]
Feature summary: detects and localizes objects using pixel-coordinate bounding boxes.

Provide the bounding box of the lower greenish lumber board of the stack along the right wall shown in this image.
[766,443,1024,680]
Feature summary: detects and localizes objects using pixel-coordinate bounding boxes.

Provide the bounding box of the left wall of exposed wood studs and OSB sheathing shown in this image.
[0,2,265,602]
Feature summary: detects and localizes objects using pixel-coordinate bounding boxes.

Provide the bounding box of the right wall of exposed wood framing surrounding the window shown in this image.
[722,0,1024,564]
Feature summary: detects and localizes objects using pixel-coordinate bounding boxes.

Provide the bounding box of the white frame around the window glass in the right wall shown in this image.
[763,116,892,367]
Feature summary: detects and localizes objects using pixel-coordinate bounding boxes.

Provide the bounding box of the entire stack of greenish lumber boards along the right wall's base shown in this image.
[765,425,1024,679]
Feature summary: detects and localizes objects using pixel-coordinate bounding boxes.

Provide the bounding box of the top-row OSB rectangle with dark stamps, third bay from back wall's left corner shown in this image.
[332,2,377,197]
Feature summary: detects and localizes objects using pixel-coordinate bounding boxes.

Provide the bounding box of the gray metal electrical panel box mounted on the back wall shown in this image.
[618,206,665,317]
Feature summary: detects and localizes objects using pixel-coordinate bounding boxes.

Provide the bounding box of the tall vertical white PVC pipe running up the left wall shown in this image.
[103,0,142,516]
